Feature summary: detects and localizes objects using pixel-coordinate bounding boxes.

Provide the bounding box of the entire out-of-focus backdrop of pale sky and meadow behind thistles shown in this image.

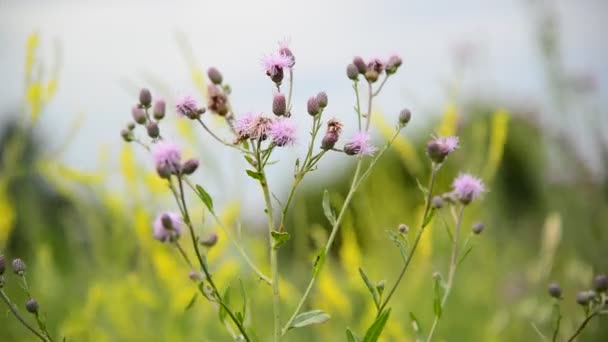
[0,0,608,341]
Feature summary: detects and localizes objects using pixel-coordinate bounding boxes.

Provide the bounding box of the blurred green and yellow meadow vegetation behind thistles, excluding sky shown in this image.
[0,0,608,341]
